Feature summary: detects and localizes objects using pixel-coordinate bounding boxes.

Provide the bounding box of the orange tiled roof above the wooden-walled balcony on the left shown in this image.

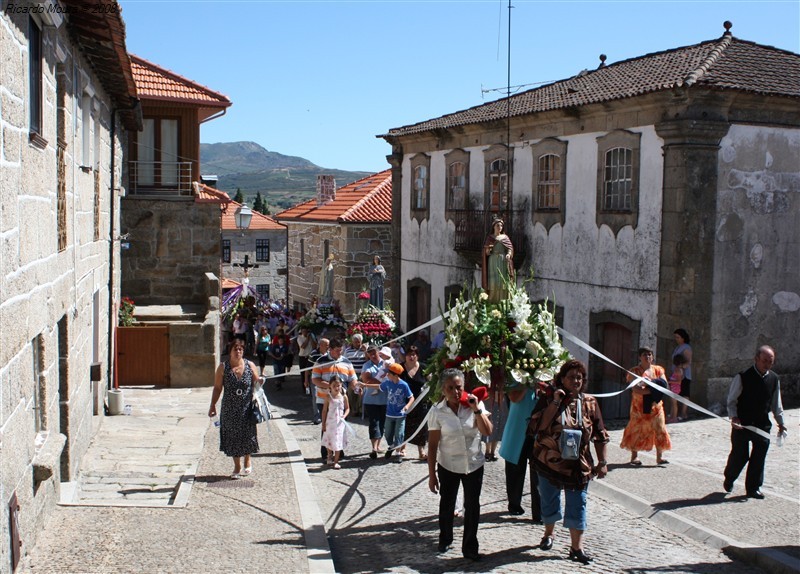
[131,54,231,108]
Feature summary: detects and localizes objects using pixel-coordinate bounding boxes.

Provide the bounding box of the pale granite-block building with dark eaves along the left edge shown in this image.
[0,4,141,572]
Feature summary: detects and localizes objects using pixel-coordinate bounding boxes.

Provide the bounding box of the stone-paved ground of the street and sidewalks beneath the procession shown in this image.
[18,377,800,574]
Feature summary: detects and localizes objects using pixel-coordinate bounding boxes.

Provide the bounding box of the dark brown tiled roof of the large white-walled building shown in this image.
[384,32,800,137]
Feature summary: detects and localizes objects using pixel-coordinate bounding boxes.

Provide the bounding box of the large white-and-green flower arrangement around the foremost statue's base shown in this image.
[425,283,569,402]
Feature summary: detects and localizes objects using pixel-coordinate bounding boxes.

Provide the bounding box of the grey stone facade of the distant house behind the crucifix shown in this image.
[222,229,287,300]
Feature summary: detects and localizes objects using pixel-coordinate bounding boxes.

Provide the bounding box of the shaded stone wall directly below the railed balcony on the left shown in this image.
[121,197,221,305]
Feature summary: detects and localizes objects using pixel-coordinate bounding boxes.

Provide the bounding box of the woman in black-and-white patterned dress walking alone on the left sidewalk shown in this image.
[208,335,258,480]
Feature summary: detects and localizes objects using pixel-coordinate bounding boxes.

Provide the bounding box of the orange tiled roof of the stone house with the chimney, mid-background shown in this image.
[275,169,392,223]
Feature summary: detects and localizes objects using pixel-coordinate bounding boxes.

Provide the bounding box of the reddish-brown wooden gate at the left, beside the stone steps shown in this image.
[117,326,170,386]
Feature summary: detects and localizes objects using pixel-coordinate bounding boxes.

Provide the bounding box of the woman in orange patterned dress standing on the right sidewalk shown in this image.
[619,347,672,466]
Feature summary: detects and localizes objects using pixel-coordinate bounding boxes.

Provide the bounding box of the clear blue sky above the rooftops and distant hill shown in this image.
[120,0,800,171]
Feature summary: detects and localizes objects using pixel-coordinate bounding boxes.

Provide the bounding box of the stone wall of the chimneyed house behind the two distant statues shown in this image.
[286,222,394,320]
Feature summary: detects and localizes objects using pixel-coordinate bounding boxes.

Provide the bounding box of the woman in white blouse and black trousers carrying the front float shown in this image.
[428,369,492,560]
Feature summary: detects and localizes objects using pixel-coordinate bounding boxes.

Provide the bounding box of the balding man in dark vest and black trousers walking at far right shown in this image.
[722,345,786,499]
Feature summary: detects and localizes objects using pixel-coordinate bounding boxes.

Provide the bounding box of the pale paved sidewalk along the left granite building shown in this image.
[17,388,333,574]
